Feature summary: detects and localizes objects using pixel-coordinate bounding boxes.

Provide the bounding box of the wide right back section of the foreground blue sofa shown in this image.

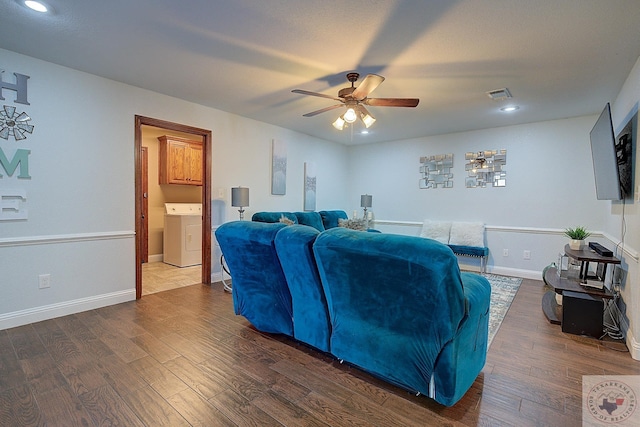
[314,228,466,391]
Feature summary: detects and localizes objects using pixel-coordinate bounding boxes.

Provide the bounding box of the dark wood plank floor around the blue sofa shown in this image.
[0,280,640,427]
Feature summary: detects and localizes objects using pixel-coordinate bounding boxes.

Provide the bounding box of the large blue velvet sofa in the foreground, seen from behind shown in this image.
[216,221,491,406]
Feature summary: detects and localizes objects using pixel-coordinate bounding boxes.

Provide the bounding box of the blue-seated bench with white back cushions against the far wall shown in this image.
[420,219,489,273]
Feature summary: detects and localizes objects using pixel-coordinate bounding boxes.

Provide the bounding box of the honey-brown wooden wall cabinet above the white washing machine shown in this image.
[158,135,203,185]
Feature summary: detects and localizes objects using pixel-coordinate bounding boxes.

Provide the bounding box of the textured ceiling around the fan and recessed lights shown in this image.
[0,0,640,144]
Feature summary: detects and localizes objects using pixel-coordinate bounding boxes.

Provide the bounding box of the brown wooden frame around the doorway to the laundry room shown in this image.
[134,115,211,299]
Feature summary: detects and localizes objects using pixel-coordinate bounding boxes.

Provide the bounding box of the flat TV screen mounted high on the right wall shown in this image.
[590,103,622,200]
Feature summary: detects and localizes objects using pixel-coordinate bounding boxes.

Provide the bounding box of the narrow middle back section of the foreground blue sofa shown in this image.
[275,224,331,352]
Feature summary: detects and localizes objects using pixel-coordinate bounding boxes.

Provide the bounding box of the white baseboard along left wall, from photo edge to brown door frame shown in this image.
[0,289,136,330]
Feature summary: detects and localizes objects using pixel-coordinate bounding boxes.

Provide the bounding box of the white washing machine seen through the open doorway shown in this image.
[163,203,202,267]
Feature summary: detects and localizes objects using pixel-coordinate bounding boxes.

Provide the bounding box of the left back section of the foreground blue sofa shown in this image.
[215,221,293,336]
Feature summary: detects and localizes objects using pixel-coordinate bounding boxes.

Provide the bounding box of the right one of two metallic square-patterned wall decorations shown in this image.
[464,150,507,188]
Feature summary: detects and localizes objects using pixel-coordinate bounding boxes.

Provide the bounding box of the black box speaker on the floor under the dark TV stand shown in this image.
[562,291,604,338]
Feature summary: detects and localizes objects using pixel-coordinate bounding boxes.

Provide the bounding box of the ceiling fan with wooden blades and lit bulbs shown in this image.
[291,73,420,130]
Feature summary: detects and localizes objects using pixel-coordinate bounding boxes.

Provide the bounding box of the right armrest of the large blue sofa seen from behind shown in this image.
[430,272,491,406]
